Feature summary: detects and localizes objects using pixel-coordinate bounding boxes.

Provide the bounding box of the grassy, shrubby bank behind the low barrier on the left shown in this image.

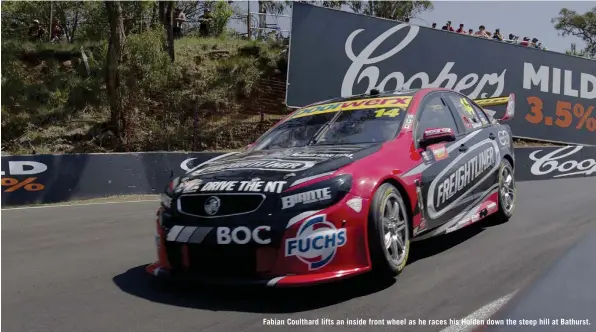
[2,25,283,153]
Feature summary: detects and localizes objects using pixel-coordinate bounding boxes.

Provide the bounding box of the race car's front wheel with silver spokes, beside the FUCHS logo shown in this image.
[368,183,411,278]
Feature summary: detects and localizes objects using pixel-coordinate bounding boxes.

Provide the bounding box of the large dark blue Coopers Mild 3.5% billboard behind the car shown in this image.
[287,3,596,145]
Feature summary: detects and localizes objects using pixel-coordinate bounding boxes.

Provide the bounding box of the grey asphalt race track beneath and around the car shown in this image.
[2,178,596,332]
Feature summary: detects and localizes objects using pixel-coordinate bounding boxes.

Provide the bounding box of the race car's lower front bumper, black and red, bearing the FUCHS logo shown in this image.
[146,194,371,287]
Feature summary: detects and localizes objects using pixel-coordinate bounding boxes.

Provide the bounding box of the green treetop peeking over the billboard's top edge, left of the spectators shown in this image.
[348,1,433,21]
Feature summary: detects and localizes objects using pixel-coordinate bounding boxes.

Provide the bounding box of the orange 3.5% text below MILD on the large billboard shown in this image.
[526,97,596,132]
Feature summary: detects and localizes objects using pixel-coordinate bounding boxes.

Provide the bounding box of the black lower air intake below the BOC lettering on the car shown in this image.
[166,242,257,277]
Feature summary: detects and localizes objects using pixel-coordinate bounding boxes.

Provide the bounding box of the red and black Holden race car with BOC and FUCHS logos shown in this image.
[146,88,516,287]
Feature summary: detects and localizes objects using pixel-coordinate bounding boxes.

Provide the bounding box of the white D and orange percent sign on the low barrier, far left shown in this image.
[0,161,48,193]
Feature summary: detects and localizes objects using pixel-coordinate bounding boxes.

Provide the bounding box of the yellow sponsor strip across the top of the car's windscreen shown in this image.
[292,96,412,119]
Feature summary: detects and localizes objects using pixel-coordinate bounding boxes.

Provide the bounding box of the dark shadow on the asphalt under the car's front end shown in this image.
[113,265,395,313]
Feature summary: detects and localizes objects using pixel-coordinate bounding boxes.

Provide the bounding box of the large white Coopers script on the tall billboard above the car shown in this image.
[341,24,507,99]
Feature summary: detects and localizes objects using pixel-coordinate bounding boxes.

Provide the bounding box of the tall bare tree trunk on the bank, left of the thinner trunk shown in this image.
[104,1,126,147]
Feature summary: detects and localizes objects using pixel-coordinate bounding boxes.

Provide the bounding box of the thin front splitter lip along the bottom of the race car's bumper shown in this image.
[145,262,369,288]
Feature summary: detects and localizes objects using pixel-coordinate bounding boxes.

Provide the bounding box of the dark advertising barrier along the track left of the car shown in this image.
[1,152,221,206]
